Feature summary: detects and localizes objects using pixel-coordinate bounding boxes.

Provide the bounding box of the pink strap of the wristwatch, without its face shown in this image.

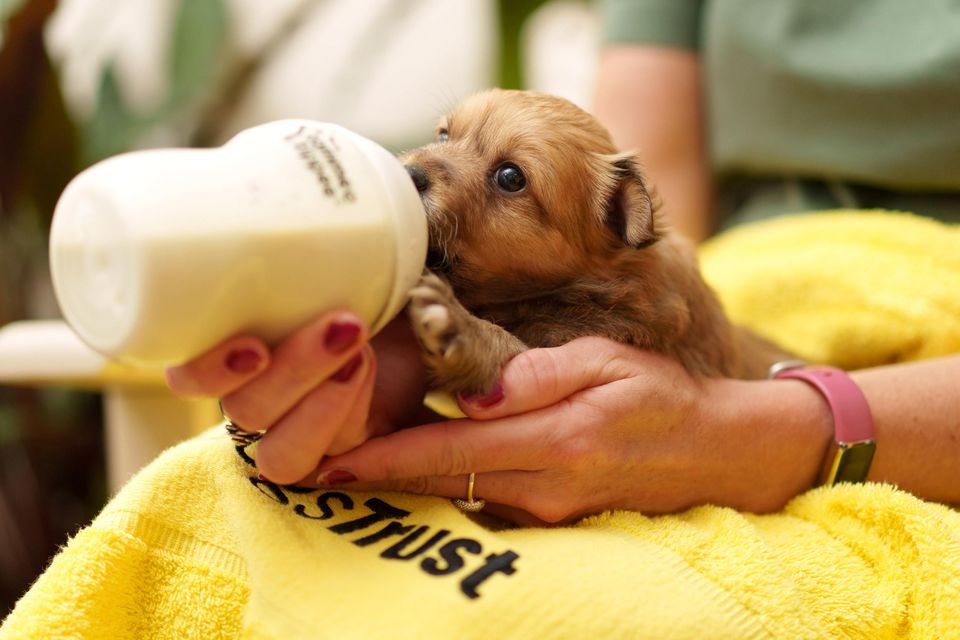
[773,366,874,444]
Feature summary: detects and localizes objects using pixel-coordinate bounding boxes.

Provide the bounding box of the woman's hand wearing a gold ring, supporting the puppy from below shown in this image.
[310,338,831,523]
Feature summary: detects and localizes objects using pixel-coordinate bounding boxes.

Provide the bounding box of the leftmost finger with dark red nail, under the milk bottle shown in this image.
[164,336,270,398]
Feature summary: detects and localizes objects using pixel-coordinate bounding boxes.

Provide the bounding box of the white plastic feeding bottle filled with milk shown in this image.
[50,120,427,364]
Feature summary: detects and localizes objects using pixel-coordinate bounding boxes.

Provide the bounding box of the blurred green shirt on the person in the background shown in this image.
[604,0,960,225]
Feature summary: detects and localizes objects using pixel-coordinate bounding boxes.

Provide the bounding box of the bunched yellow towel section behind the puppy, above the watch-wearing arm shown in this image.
[700,211,960,369]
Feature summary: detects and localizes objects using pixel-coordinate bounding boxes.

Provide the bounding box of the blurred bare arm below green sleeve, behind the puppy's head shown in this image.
[594,46,712,241]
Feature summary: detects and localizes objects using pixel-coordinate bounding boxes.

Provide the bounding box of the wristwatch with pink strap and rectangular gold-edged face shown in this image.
[767,360,877,486]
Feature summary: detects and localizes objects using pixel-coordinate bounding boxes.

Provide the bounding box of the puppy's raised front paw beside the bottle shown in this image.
[409,273,471,365]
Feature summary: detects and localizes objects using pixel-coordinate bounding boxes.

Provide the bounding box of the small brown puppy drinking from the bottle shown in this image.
[401,90,785,392]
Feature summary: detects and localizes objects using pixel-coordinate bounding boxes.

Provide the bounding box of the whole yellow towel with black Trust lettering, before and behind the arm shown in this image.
[0,209,960,640]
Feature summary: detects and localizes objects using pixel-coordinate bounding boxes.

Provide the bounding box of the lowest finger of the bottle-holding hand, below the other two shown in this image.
[256,349,371,484]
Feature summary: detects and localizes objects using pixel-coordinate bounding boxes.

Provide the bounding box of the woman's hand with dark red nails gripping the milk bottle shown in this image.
[166,311,426,484]
